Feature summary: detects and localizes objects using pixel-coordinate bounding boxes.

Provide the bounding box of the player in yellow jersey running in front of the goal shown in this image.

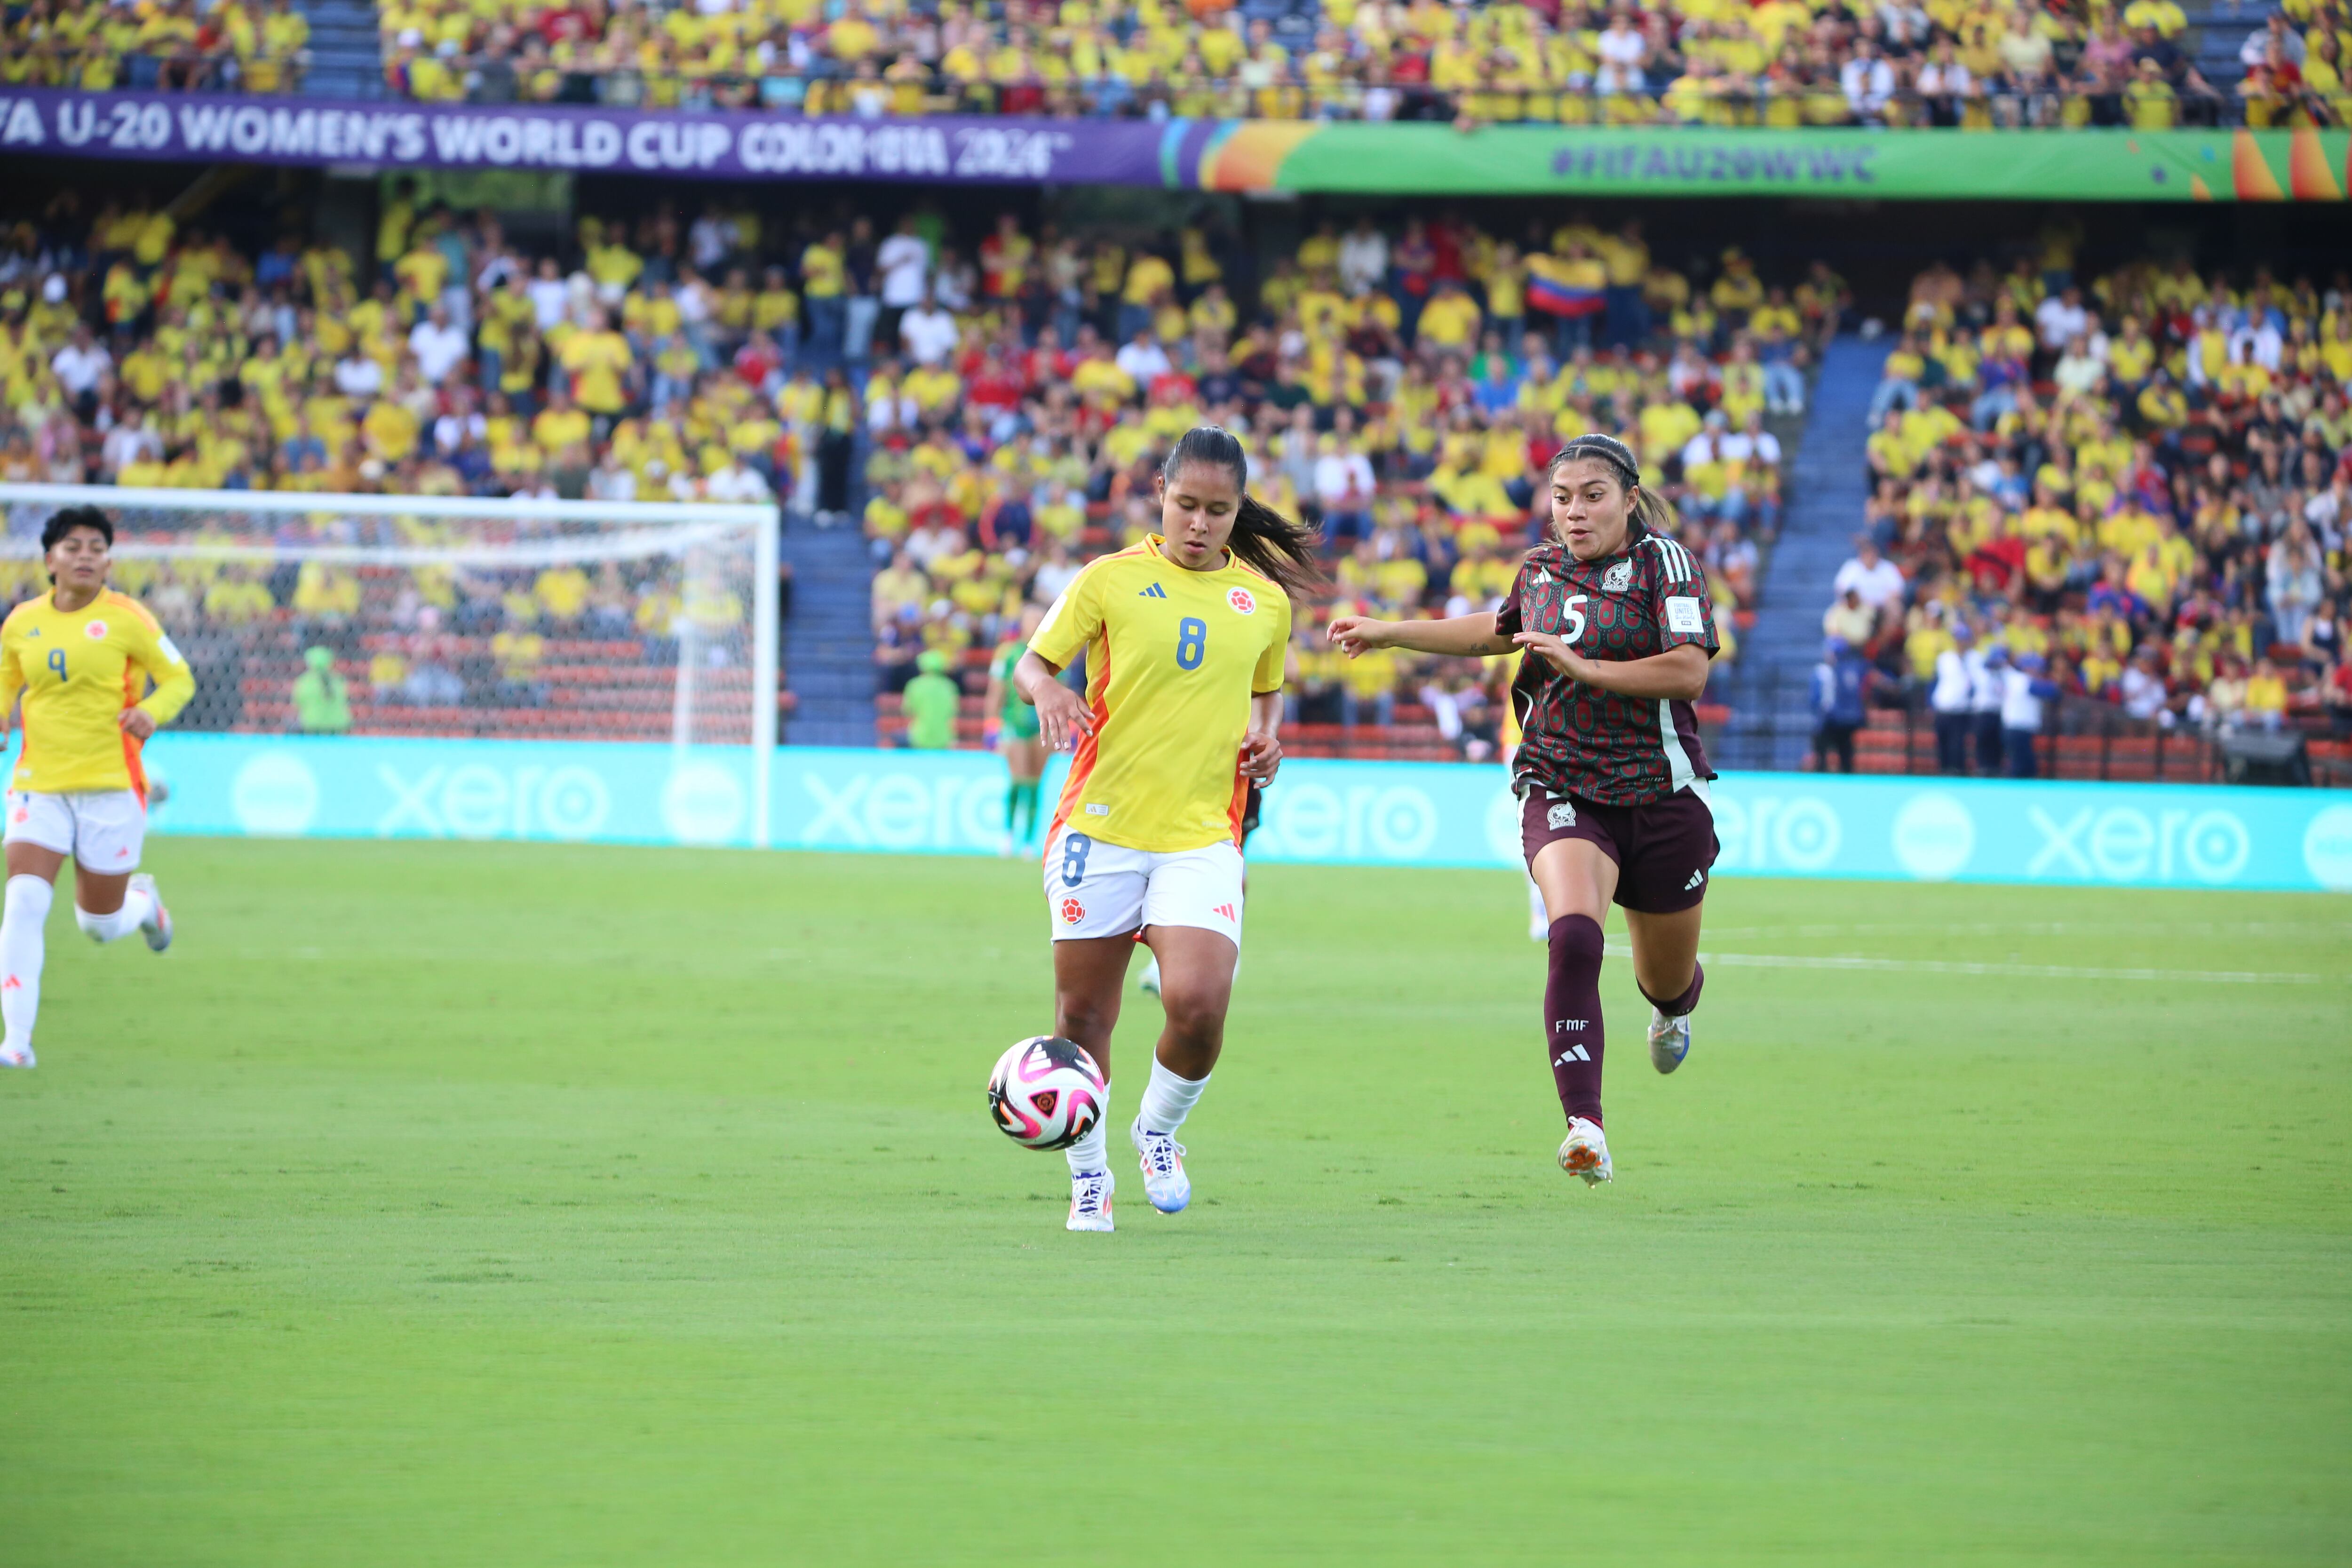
[0,505,195,1067]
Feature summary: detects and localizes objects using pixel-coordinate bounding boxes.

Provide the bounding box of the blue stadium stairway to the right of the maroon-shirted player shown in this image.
[1715,336,1886,769]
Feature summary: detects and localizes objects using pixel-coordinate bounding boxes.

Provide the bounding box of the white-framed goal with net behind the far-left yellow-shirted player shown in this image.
[0,484,779,842]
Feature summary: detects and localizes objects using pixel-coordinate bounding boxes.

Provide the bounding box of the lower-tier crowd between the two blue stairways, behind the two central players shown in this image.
[828,207,1797,755]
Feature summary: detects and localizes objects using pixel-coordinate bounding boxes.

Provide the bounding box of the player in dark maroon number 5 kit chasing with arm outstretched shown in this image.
[1331,435,1719,1182]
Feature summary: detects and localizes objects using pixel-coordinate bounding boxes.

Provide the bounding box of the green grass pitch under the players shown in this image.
[0,839,2352,1568]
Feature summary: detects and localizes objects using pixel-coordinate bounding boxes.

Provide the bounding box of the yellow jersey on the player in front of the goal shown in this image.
[0,588,195,799]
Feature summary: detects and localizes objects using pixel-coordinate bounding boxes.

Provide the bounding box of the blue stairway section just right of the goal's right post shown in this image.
[783,517,875,745]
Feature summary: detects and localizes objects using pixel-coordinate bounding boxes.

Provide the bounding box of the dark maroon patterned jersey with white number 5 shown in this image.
[1494,531,1722,806]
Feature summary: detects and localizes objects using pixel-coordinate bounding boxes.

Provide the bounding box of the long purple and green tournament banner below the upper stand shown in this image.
[0,89,2352,202]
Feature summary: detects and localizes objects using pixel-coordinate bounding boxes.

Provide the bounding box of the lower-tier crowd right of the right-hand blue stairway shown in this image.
[1823,228,2352,773]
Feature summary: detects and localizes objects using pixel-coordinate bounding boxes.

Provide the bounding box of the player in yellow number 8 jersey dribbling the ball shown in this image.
[1014,425,1317,1229]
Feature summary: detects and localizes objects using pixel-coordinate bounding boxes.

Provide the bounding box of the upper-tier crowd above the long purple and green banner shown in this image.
[0,0,2352,129]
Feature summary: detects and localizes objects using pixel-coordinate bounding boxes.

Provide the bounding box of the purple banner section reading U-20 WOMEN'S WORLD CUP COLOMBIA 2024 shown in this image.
[0,89,1185,186]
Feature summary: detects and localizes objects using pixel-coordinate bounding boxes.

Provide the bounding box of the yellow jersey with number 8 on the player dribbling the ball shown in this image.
[1030,533,1291,853]
